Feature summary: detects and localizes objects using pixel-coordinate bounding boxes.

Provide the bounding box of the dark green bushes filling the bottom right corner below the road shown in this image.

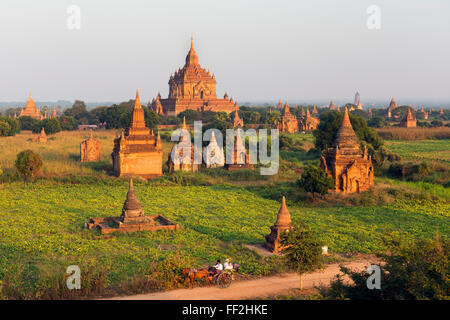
[322,236,450,300]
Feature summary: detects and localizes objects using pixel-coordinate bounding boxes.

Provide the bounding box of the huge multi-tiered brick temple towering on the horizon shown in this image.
[149,38,235,115]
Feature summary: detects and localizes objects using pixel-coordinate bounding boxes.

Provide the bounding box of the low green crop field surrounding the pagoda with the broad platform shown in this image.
[0,181,450,292]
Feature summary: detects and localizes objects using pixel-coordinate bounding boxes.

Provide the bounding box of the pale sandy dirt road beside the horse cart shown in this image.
[112,260,370,300]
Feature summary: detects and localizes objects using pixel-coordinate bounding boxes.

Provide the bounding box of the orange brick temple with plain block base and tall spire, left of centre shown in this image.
[111,91,163,178]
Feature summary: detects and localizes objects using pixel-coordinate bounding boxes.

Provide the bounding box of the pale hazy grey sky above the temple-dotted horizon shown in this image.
[0,0,450,102]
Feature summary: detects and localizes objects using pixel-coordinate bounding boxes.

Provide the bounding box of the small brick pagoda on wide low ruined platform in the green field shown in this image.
[85,179,179,234]
